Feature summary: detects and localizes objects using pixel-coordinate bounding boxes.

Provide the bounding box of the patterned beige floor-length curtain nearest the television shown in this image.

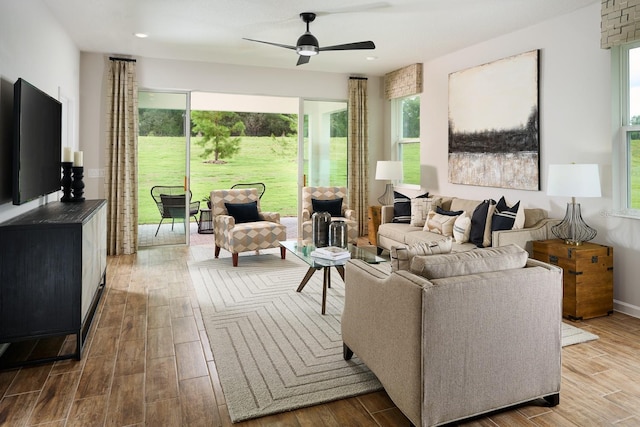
[105,58,138,255]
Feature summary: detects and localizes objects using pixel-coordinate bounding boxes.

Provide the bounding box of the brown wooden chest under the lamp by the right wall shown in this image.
[533,239,613,320]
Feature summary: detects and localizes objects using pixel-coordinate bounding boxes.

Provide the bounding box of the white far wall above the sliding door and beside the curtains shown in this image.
[80,53,384,201]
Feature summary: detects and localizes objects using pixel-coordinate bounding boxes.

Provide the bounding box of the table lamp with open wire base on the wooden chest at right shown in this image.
[547,163,602,246]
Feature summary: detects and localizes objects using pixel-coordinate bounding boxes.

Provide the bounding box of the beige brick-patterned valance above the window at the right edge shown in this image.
[600,0,640,49]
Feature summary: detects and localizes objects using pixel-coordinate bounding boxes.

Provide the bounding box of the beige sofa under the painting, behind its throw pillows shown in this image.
[377,196,559,255]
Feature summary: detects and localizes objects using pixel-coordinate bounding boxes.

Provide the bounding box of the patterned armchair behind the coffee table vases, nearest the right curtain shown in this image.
[302,187,358,244]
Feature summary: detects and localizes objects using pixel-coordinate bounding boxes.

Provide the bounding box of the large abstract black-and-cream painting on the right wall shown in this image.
[449,50,540,190]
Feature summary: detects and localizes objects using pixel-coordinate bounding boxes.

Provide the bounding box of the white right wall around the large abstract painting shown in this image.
[410,3,640,316]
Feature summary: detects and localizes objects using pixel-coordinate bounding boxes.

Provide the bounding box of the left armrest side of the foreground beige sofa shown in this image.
[341,259,429,425]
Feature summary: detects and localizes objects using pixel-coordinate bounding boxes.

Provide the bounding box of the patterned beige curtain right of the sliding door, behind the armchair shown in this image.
[348,77,369,236]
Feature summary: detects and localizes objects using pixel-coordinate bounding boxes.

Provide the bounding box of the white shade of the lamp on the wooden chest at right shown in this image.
[547,163,602,197]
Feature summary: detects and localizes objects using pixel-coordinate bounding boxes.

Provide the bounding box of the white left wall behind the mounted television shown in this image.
[0,0,80,221]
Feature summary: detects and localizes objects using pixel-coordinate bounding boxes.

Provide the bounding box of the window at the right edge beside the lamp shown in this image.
[613,42,640,216]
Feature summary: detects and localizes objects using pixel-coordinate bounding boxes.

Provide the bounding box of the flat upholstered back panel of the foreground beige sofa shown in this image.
[421,260,562,426]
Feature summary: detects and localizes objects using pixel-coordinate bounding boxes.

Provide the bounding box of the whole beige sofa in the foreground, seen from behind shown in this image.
[342,245,562,426]
